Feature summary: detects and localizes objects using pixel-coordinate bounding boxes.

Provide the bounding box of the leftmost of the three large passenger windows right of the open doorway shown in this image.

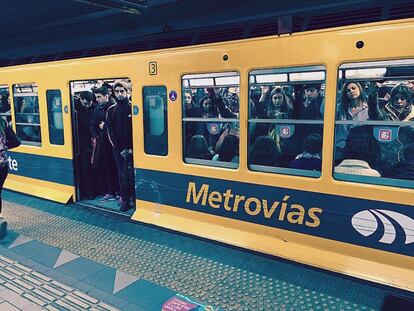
[182,72,240,168]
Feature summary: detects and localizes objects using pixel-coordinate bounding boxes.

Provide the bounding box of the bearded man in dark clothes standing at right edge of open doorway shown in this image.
[106,82,134,212]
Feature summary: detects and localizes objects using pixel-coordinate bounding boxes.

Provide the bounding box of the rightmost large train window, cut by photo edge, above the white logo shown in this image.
[334,59,414,188]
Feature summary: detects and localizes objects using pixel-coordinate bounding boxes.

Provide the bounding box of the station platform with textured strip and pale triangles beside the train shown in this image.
[0,191,414,311]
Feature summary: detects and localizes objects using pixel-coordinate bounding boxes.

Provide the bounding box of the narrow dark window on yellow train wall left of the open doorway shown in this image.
[46,90,64,145]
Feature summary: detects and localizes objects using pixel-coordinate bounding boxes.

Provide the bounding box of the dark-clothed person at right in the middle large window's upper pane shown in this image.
[299,83,323,120]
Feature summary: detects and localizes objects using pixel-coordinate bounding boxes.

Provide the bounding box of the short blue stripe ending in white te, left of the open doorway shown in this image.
[9,152,75,186]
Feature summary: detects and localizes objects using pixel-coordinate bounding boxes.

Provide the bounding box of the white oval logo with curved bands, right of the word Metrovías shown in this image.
[352,209,414,244]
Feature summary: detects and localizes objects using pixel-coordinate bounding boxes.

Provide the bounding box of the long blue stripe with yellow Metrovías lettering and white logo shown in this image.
[135,169,414,256]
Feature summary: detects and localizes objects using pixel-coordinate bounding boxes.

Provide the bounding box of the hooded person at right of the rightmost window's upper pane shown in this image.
[368,82,414,121]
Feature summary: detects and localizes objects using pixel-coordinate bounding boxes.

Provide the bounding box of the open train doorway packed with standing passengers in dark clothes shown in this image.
[71,79,134,212]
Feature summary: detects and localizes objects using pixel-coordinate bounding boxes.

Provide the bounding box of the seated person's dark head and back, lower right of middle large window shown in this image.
[289,133,322,171]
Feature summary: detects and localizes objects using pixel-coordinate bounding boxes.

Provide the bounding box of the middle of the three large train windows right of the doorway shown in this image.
[248,66,326,177]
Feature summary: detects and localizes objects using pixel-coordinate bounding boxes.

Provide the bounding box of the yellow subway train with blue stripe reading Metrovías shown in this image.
[0,19,414,291]
